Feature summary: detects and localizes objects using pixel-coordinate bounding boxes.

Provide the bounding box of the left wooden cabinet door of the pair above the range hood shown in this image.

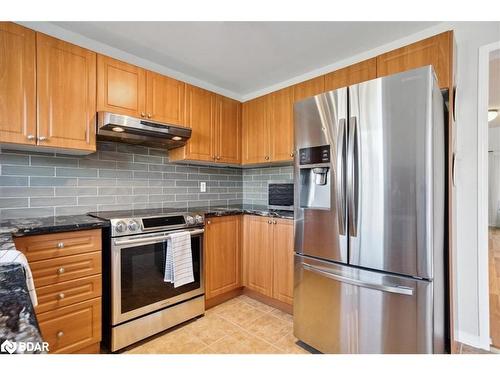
[97,55,146,117]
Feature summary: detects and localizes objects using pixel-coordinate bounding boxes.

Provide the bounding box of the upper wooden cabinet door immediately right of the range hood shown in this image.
[185,85,215,161]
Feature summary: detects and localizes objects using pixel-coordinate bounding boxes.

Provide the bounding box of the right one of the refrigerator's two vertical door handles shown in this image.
[347,116,359,237]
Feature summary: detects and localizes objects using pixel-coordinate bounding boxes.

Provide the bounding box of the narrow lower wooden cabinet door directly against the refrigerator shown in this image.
[273,219,293,305]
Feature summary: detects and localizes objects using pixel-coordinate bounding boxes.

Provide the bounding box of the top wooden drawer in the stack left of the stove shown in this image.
[14,229,101,262]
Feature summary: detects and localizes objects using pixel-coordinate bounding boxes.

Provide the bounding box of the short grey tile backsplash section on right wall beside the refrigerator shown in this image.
[243,165,293,205]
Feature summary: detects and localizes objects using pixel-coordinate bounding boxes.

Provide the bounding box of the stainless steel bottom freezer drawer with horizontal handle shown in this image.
[294,255,444,353]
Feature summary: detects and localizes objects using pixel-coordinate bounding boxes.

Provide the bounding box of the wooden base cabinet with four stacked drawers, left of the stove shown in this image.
[14,229,102,353]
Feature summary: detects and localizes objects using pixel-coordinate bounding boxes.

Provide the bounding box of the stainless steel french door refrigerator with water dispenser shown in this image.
[294,66,447,353]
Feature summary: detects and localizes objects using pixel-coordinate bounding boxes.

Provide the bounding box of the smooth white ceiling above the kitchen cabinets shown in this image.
[53,22,438,97]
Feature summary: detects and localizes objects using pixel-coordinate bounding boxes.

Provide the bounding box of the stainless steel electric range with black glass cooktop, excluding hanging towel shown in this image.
[90,209,205,351]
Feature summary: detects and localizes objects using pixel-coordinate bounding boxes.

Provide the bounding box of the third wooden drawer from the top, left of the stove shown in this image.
[35,275,101,314]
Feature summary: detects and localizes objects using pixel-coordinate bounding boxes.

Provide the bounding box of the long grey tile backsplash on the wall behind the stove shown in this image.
[0,142,244,219]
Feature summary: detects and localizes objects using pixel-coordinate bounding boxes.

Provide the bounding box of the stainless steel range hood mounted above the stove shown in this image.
[97,112,191,149]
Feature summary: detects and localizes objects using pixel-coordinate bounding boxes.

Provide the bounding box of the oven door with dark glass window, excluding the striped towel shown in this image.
[111,229,204,325]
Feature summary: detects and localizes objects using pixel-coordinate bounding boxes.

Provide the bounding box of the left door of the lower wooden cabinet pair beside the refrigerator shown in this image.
[243,215,273,297]
